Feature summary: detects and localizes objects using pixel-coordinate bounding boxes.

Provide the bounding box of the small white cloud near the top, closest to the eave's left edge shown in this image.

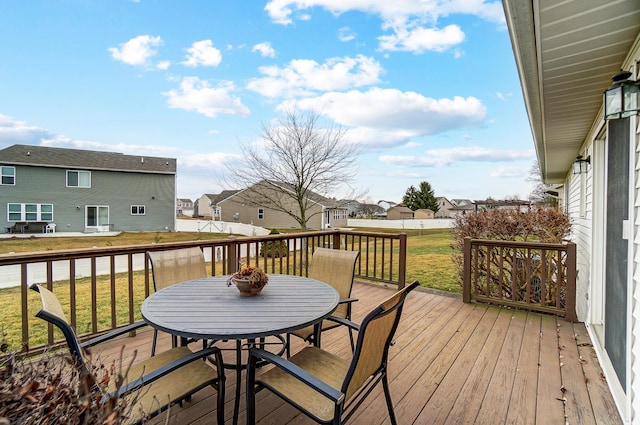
[378,25,465,53]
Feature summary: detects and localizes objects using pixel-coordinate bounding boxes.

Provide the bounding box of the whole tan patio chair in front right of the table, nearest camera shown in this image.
[246,281,419,425]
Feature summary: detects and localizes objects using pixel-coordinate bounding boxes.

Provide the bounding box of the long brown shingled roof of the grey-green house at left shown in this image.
[0,145,176,174]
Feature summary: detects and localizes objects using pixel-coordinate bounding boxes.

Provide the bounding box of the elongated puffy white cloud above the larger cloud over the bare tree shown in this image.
[247,55,383,98]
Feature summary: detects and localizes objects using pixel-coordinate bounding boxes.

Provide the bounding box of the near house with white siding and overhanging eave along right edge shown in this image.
[503,0,640,424]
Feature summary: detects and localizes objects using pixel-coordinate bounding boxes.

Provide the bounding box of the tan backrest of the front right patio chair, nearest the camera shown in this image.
[342,281,420,400]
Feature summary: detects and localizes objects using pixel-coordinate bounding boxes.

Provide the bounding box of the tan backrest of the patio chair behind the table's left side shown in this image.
[147,246,207,291]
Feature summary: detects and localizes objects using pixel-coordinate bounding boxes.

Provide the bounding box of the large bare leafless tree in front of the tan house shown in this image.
[227,110,359,230]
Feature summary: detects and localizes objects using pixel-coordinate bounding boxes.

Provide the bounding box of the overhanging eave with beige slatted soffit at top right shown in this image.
[503,0,640,184]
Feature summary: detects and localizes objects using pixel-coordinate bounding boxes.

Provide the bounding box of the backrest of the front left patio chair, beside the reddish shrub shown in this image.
[30,284,92,376]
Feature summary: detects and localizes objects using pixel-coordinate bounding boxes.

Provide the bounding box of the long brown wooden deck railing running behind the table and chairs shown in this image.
[0,230,407,352]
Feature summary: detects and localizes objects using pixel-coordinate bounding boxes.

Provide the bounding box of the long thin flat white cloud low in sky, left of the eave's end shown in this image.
[379,146,535,167]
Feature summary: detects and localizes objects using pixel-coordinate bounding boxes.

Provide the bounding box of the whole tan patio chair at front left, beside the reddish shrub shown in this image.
[31,284,225,425]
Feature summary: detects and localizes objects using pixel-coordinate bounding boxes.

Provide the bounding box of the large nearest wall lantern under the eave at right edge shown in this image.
[604,70,640,119]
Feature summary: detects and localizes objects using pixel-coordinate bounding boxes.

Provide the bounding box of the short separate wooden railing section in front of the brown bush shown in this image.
[462,238,577,322]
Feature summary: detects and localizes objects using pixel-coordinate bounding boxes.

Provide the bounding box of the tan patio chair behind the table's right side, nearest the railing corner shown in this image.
[287,248,360,357]
